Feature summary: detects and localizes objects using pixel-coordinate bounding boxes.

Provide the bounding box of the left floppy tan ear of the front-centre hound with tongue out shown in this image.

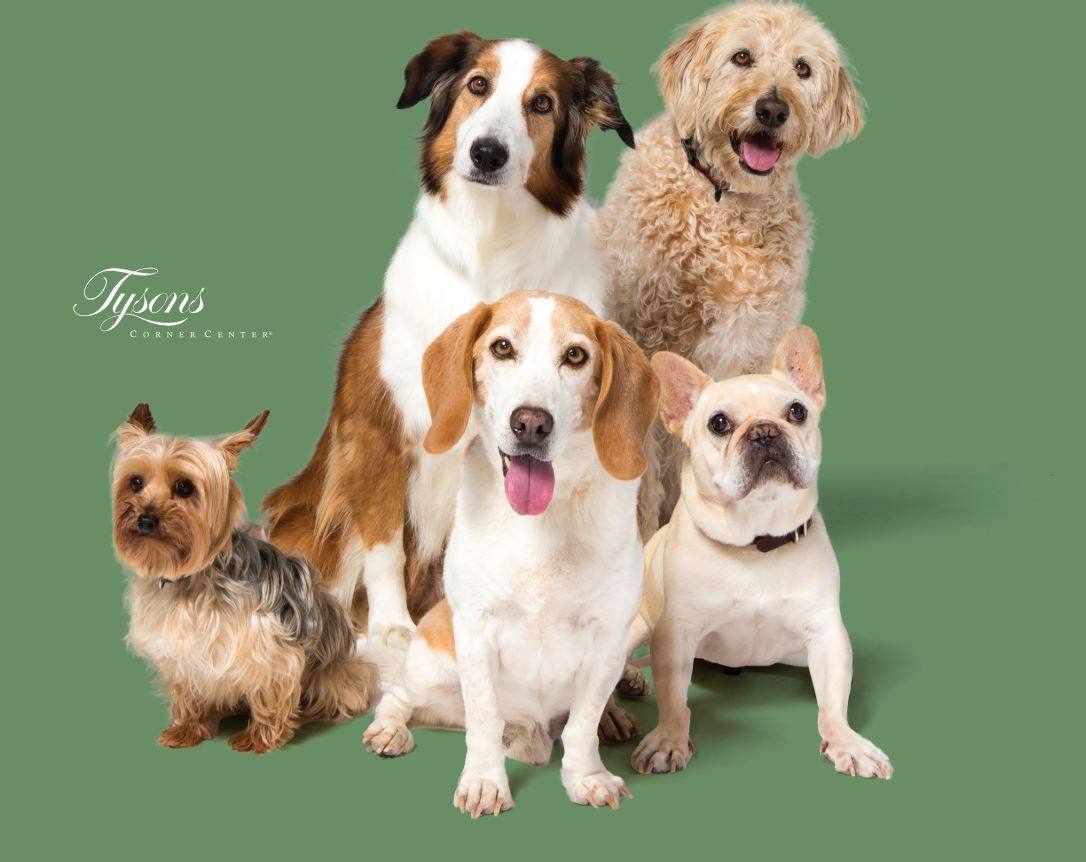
[422,303,493,455]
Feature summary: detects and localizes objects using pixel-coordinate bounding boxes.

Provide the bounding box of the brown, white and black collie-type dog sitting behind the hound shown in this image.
[264,33,633,644]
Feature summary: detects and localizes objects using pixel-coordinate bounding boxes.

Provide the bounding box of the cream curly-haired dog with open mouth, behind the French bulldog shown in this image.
[599,2,863,537]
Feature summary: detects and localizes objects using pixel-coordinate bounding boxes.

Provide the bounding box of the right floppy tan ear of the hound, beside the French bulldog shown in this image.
[592,320,660,481]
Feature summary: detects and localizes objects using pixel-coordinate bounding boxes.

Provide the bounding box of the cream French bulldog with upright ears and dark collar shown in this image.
[631,327,893,778]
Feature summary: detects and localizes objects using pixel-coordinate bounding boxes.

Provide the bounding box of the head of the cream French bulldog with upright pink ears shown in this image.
[653,327,825,503]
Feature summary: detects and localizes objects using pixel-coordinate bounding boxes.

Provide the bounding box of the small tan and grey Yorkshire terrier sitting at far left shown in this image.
[113,404,377,753]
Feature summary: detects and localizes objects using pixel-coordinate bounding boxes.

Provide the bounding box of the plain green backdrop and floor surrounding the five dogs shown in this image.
[0,0,1083,860]
